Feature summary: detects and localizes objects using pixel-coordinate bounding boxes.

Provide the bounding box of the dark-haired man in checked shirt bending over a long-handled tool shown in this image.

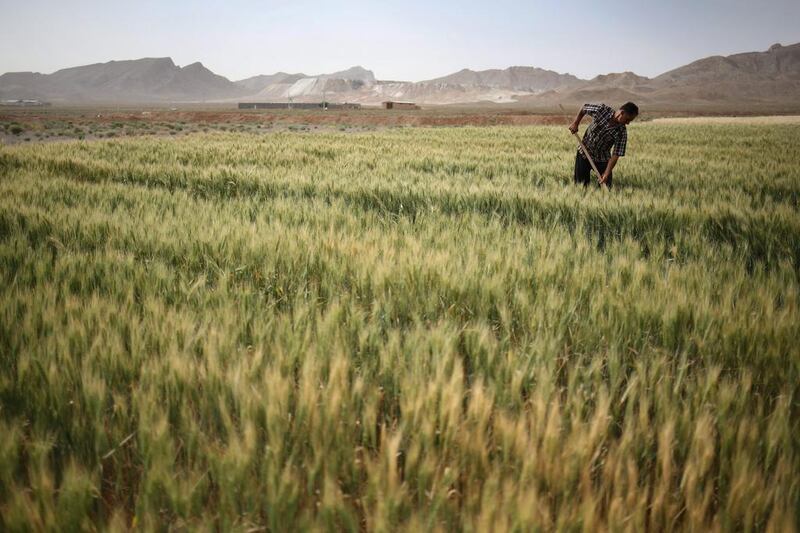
[569,102,639,187]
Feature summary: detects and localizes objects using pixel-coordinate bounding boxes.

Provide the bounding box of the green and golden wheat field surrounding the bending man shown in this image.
[0,123,800,531]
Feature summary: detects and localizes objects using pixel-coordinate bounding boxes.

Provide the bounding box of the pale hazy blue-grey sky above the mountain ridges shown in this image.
[0,0,800,81]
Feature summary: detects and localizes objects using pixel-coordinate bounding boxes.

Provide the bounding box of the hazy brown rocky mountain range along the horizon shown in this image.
[0,43,800,106]
